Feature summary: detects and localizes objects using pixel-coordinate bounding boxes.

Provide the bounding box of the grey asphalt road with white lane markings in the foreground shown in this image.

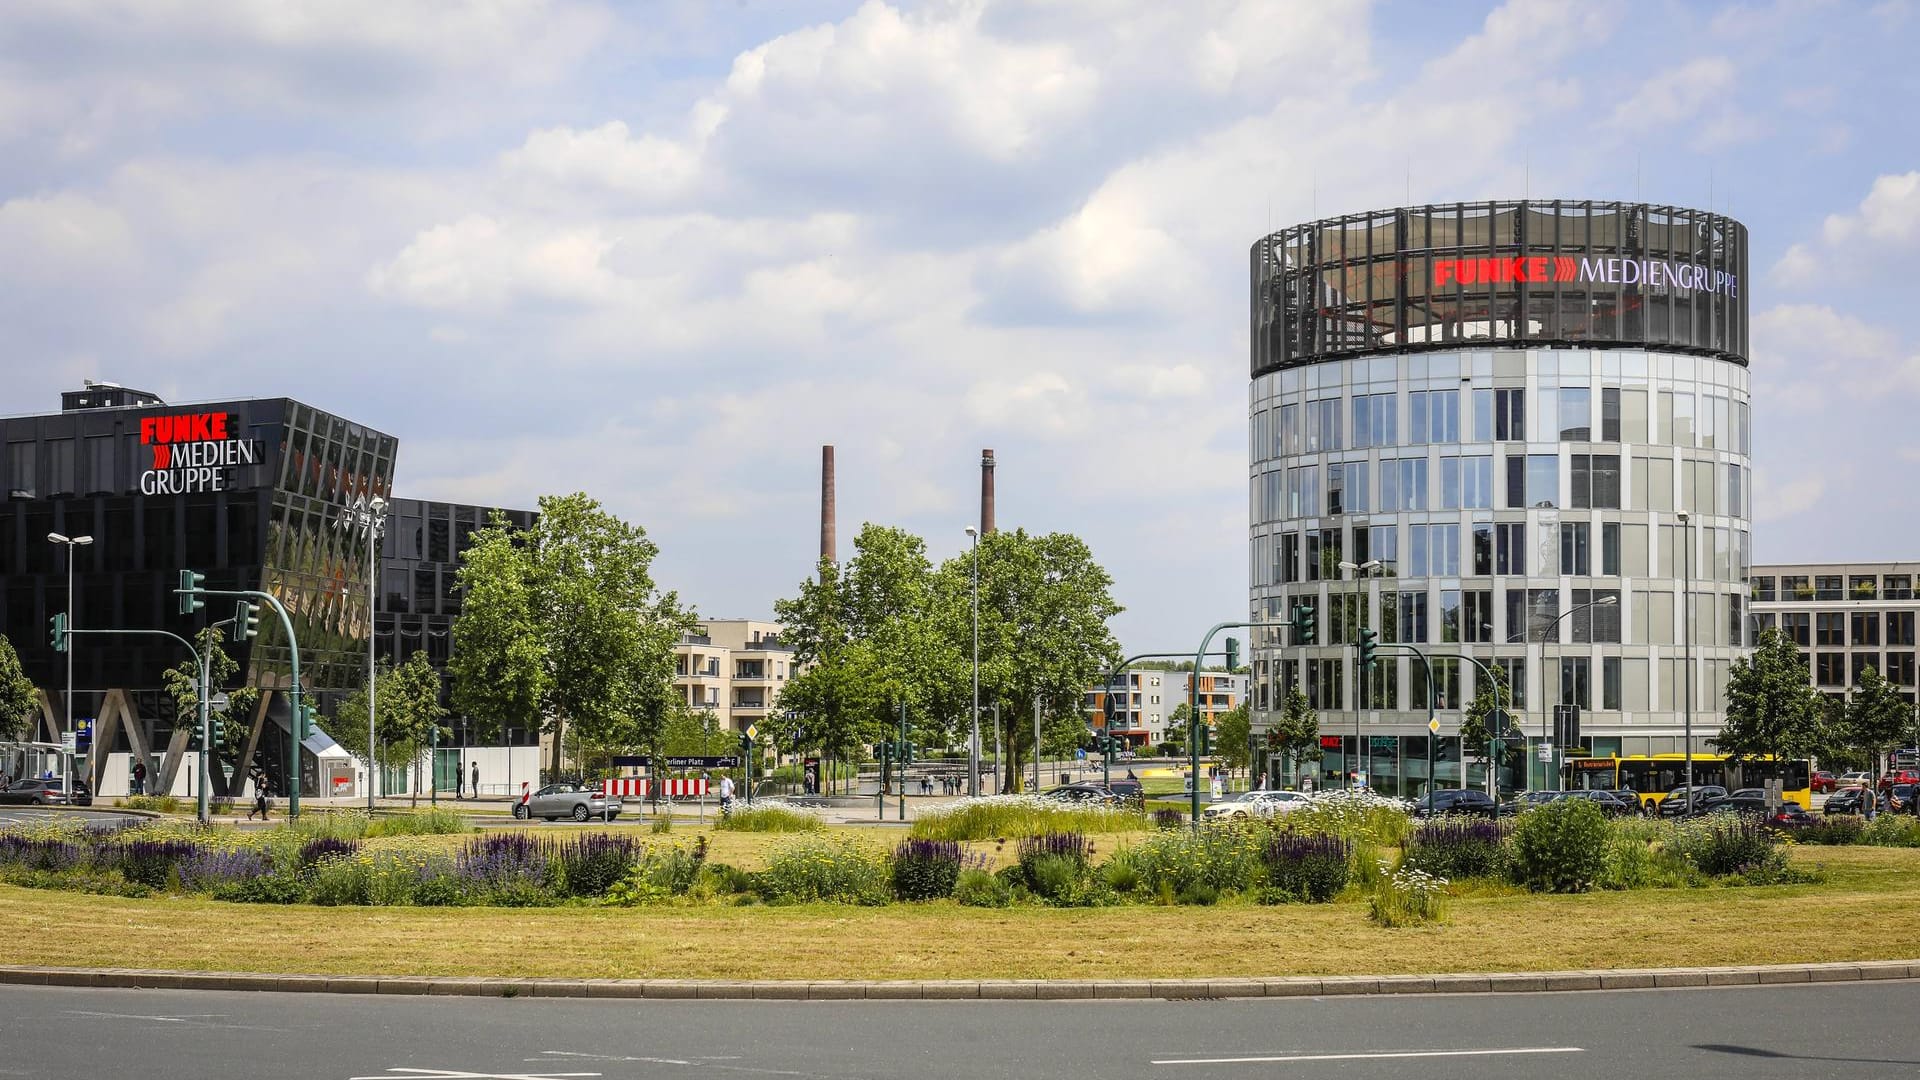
[0,980,1920,1080]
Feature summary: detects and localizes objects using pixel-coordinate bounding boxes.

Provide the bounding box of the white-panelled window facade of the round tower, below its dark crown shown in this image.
[1248,204,1751,796]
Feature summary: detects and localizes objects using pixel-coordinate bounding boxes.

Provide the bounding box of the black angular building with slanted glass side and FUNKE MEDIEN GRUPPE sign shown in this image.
[0,382,538,796]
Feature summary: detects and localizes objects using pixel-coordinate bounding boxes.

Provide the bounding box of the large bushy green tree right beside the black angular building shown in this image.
[451,492,693,773]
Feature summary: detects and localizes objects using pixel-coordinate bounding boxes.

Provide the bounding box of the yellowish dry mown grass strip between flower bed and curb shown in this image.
[0,834,1920,978]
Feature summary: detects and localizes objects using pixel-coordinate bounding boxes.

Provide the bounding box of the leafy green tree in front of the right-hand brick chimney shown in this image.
[939,528,1121,790]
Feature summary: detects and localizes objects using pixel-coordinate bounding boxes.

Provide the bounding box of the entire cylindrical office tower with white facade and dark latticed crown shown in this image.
[1250,200,1751,796]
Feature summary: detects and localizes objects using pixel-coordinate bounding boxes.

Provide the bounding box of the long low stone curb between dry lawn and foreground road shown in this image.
[0,961,1920,1001]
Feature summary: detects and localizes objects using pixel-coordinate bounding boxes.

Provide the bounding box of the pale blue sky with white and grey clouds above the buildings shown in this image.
[0,0,1920,650]
